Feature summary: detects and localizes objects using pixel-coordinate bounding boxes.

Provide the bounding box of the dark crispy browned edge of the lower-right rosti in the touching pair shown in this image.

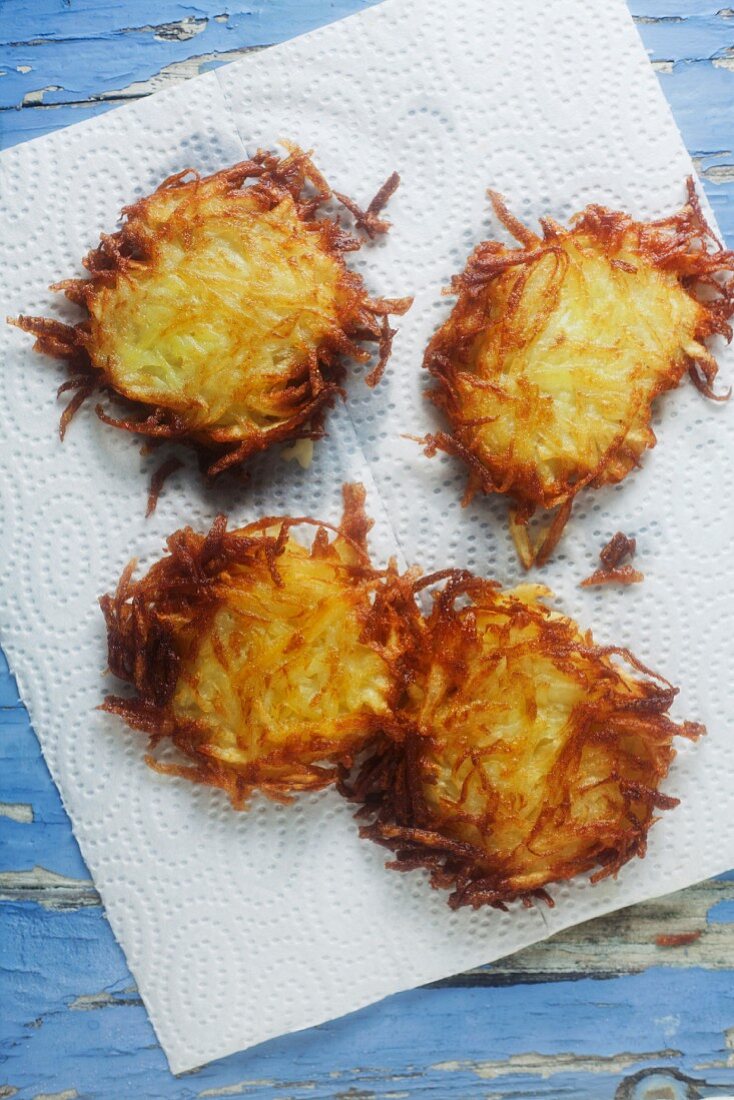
[339,570,705,910]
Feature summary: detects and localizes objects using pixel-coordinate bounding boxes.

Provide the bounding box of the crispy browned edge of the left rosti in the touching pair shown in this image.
[100,484,413,807]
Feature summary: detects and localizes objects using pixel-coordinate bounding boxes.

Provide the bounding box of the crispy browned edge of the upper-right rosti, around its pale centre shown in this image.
[421,177,734,569]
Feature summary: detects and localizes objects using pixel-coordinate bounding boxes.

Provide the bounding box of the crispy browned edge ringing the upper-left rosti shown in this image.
[8,146,413,486]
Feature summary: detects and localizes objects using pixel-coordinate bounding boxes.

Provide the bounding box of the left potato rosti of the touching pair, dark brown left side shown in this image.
[101,486,402,805]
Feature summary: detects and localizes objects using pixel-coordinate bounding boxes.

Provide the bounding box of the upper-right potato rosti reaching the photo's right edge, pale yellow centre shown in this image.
[424,180,734,568]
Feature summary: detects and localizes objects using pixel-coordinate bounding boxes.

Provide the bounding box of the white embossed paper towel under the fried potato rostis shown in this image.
[0,0,734,1073]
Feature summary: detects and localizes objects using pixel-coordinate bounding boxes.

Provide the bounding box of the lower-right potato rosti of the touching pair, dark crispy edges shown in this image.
[342,573,703,908]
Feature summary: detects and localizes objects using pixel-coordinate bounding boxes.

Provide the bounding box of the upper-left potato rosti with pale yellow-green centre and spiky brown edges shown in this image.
[14,146,410,486]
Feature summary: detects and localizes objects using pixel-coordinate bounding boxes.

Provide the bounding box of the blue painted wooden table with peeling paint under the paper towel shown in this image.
[0,0,734,1100]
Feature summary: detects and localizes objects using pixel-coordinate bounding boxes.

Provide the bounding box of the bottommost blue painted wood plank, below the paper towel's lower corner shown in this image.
[0,937,734,1100]
